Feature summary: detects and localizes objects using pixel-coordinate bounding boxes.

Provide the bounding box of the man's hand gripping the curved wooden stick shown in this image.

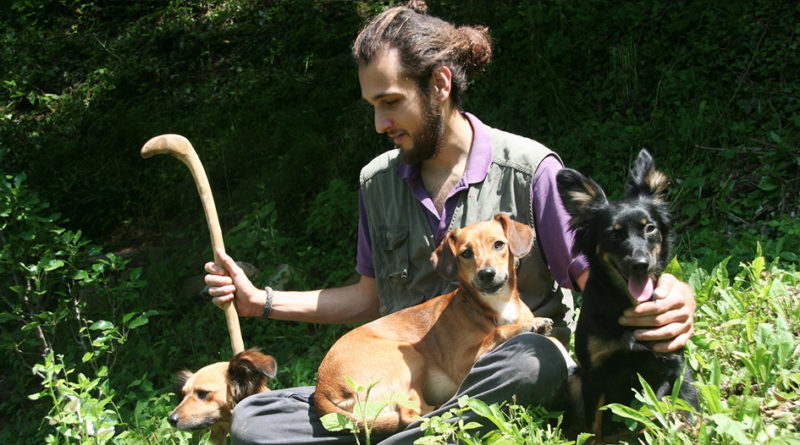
[205,249,267,317]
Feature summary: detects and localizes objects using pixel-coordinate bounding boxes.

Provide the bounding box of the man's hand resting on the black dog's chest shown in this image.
[619,274,697,352]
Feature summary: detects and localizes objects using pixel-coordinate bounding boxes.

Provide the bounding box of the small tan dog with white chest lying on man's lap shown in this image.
[314,215,557,433]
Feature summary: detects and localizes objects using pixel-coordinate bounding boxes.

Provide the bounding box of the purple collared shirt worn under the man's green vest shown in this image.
[356,113,588,290]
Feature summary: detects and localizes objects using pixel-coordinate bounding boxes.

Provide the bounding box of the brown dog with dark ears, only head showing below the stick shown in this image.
[167,349,278,444]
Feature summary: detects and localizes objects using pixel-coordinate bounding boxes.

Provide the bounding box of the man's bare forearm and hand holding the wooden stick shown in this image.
[205,246,379,323]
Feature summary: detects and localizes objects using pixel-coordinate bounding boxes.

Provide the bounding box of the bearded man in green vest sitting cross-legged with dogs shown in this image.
[206,7,695,443]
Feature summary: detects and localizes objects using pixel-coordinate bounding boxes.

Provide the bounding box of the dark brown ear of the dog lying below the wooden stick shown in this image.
[228,349,278,402]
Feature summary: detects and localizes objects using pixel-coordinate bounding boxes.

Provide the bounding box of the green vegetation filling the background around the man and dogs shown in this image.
[0,0,800,443]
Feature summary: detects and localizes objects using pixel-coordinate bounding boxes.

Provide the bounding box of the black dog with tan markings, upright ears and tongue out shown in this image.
[557,150,698,438]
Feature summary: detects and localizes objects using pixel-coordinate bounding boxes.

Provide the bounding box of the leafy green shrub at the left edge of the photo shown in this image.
[0,158,158,443]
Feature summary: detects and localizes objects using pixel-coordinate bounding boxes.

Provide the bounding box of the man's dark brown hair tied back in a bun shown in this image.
[352,2,492,109]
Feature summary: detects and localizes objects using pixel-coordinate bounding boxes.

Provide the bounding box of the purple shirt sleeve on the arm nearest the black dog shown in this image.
[531,156,589,291]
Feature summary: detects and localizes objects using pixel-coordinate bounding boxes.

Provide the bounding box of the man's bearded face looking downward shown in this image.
[358,48,444,164]
